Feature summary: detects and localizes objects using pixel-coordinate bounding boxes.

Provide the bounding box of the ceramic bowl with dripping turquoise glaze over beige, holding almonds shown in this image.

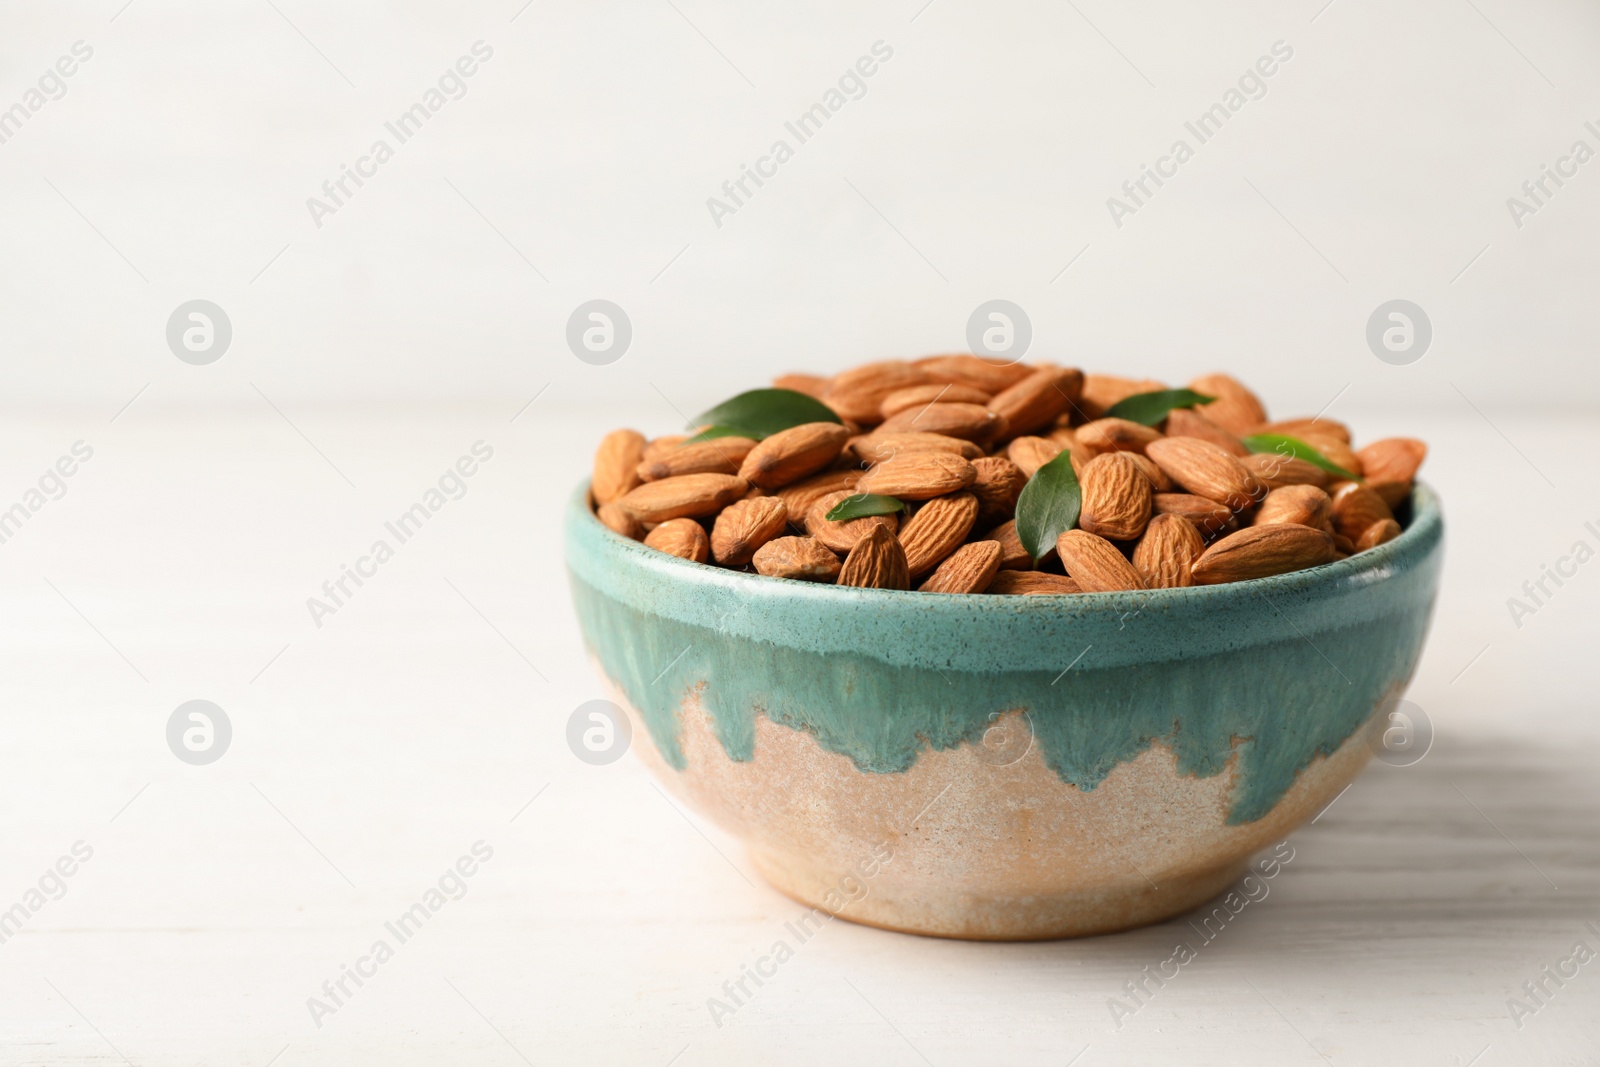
[566,485,1443,939]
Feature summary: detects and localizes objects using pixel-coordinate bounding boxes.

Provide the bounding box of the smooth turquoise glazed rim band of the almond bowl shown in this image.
[566,482,1443,672]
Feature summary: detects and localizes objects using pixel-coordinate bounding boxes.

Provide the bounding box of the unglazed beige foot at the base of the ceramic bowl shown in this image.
[749,848,1250,941]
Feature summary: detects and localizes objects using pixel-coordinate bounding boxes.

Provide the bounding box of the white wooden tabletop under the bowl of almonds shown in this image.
[0,404,1600,1067]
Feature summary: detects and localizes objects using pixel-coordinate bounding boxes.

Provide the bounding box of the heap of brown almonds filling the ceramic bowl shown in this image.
[590,355,1427,593]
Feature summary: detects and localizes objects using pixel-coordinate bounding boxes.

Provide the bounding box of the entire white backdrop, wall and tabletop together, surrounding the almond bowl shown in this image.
[0,0,1600,1067]
